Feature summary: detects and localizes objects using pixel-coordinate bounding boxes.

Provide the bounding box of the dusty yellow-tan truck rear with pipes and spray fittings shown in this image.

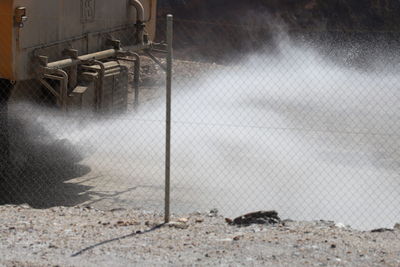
[0,0,157,112]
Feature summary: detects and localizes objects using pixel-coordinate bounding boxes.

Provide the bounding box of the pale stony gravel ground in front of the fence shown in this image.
[0,206,400,266]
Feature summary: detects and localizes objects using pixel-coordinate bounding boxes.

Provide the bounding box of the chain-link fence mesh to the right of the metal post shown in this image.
[162,17,399,228]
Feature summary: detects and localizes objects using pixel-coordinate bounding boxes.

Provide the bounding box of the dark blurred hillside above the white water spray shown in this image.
[158,0,400,62]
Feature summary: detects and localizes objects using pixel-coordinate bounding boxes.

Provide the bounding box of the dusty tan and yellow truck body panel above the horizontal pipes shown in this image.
[0,0,157,81]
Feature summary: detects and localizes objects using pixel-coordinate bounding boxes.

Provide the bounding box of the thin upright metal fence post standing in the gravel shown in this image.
[165,15,173,223]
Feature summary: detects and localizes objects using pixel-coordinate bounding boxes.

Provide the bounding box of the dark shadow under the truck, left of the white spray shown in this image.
[0,107,90,208]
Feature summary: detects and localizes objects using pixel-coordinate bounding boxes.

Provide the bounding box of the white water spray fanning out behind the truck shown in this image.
[8,34,400,229]
